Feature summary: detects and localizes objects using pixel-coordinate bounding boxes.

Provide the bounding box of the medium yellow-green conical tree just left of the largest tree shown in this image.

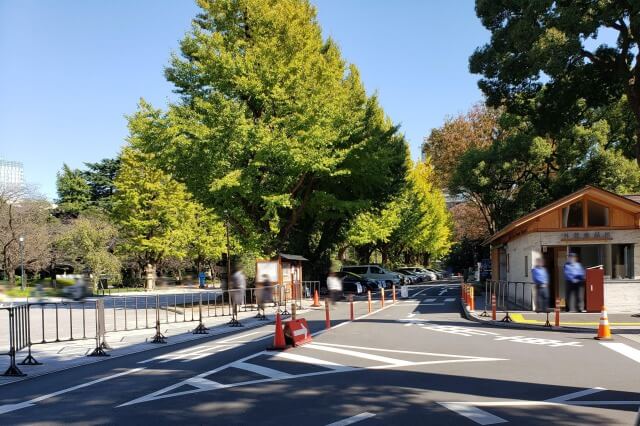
[113,147,197,287]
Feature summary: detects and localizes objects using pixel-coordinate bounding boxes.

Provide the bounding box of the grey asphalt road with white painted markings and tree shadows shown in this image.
[0,283,640,426]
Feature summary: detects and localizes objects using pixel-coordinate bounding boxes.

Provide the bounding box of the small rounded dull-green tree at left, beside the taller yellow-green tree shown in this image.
[57,214,122,291]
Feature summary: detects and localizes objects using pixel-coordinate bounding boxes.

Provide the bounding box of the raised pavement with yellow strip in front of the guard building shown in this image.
[464,295,640,333]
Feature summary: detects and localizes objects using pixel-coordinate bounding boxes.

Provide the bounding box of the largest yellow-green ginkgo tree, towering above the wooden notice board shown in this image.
[130,0,407,266]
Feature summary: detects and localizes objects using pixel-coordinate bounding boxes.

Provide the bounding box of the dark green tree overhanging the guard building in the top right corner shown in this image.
[470,0,640,162]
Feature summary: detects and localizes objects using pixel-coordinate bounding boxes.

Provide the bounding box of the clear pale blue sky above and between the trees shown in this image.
[0,0,489,198]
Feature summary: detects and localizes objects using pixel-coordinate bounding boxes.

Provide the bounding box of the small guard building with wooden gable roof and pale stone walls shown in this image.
[485,186,640,312]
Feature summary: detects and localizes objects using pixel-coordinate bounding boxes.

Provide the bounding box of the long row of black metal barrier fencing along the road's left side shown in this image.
[0,281,320,376]
